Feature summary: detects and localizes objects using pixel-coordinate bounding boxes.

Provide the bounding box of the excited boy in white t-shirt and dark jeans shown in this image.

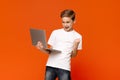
[36,9,82,80]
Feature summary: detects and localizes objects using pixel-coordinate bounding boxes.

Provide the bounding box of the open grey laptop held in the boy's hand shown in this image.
[30,28,61,53]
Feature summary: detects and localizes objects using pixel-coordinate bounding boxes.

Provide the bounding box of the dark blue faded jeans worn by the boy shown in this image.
[45,66,71,80]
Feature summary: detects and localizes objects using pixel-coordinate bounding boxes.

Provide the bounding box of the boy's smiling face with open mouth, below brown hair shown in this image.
[62,17,74,32]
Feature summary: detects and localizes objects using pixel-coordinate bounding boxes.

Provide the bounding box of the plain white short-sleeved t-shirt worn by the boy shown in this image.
[46,29,82,71]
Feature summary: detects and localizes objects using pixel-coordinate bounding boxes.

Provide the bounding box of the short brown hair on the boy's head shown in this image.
[60,9,75,21]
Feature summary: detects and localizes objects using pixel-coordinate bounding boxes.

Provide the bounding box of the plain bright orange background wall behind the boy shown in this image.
[0,0,120,80]
